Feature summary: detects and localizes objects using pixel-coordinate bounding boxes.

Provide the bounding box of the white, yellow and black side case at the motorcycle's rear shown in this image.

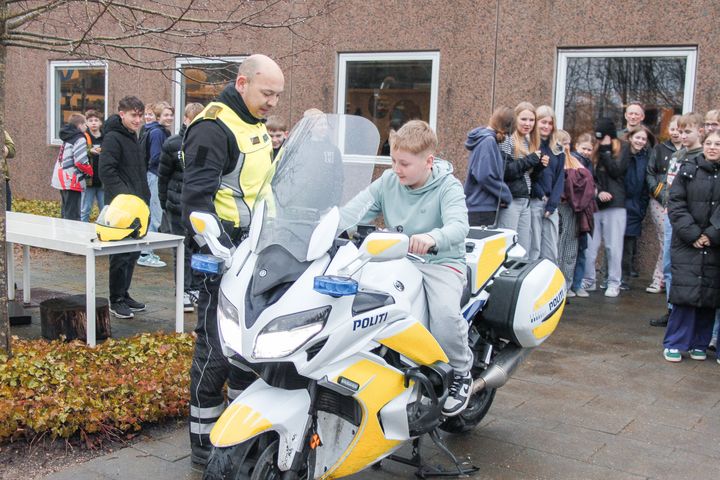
[481,259,566,348]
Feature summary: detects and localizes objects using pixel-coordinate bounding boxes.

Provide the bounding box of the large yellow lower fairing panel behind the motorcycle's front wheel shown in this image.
[320,358,406,479]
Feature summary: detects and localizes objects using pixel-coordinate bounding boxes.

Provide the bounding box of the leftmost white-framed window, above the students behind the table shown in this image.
[48,61,108,145]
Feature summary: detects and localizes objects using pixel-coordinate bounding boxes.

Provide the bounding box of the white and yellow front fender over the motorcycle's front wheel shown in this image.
[210,379,310,471]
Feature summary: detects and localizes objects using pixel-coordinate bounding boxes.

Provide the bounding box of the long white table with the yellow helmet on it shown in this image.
[5,212,185,347]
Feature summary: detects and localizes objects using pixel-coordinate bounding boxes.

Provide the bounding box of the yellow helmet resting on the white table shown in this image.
[95,194,150,242]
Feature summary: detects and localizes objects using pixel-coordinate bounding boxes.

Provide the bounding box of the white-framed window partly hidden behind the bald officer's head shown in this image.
[175,57,245,130]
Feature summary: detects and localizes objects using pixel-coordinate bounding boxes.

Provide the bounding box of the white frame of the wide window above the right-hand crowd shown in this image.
[553,47,697,128]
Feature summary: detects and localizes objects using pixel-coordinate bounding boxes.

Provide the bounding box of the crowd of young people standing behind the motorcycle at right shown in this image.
[465,102,720,363]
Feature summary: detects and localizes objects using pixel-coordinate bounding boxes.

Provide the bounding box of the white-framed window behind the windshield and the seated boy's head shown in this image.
[337,52,440,163]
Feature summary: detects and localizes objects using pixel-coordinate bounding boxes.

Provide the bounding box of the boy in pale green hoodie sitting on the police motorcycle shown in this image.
[341,120,473,416]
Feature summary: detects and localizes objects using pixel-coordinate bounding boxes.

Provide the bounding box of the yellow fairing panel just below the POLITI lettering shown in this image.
[375,318,448,365]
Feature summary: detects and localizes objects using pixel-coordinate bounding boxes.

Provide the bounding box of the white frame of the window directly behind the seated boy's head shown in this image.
[335,51,440,165]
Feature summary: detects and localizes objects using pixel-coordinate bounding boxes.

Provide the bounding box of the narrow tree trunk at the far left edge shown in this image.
[0,0,12,356]
